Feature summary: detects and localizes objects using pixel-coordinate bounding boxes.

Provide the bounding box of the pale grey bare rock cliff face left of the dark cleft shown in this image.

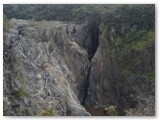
[4,19,97,115]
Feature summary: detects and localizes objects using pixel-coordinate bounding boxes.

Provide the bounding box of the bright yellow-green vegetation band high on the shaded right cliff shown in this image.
[113,30,155,54]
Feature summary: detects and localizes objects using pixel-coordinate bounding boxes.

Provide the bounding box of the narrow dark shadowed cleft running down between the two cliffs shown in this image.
[78,21,99,105]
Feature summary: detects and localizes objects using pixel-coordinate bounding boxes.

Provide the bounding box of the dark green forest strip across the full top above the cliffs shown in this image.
[4,4,155,24]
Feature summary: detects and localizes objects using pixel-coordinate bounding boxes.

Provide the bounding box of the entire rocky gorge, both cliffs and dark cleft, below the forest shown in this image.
[3,4,155,116]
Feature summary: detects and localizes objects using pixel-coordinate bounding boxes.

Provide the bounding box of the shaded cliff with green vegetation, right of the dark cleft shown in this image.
[85,23,155,115]
